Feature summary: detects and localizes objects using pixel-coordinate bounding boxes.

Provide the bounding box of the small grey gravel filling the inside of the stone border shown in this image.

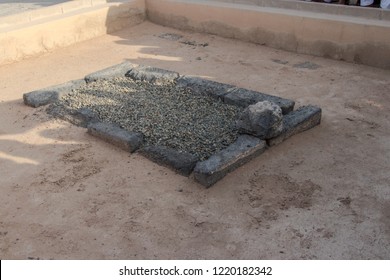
[57,77,242,160]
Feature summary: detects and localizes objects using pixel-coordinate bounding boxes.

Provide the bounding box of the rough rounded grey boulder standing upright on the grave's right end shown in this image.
[237,101,283,139]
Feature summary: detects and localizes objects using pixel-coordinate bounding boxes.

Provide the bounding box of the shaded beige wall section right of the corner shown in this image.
[146,0,390,69]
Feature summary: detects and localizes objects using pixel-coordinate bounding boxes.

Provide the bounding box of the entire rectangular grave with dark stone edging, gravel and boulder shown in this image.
[23,62,321,187]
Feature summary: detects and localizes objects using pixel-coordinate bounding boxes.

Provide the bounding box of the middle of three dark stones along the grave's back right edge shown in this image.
[177,76,235,99]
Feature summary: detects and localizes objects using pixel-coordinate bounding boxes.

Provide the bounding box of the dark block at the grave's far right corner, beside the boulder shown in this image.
[267,106,321,146]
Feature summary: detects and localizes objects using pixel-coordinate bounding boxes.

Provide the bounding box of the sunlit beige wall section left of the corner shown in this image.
[0,0,145,65]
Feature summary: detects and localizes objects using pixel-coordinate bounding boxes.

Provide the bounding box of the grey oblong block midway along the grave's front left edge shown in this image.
[88,122,143,153]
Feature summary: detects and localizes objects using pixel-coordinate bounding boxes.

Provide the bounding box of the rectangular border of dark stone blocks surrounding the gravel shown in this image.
[23,61,321,187]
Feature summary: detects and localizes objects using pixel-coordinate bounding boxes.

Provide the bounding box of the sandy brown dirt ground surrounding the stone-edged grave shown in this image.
[0,22,390,259]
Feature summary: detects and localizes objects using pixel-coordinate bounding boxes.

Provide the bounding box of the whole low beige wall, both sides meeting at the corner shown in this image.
[0,0,390,69]
